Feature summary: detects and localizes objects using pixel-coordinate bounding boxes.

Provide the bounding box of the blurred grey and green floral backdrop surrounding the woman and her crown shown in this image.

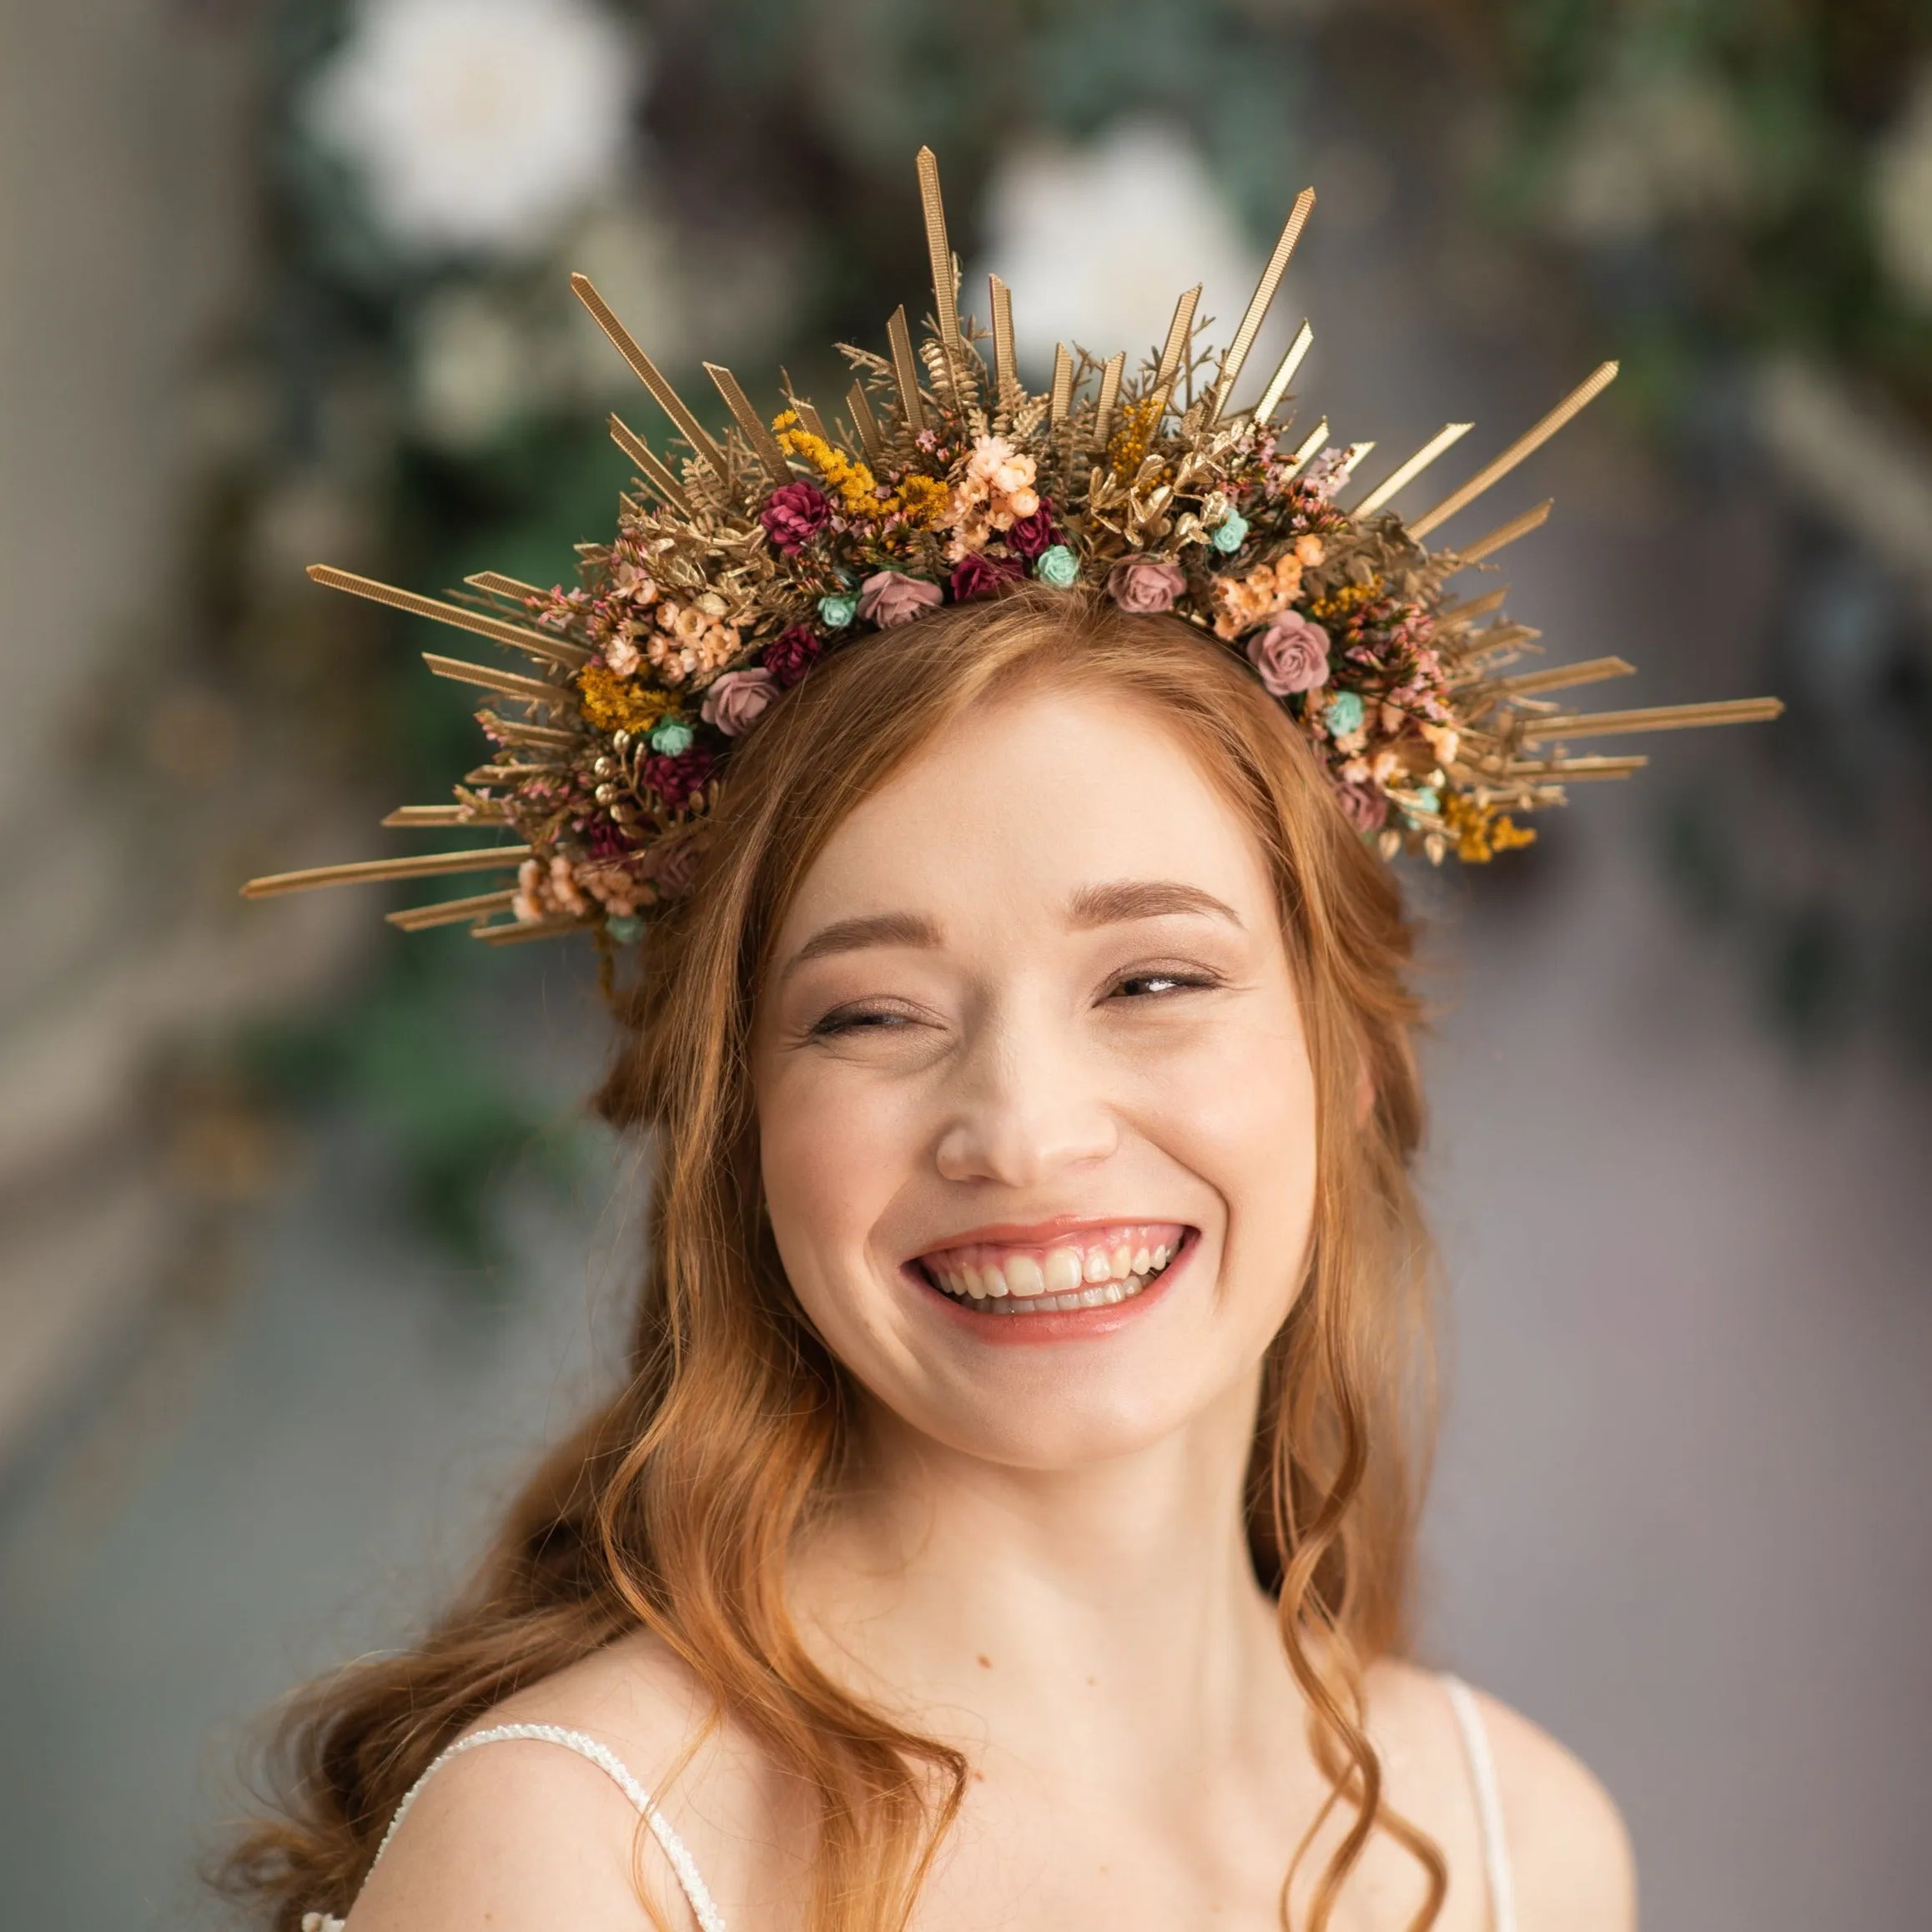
[0,0,1932,1932]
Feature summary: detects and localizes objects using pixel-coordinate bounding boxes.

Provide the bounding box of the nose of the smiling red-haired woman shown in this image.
[935,1016,1119,1188]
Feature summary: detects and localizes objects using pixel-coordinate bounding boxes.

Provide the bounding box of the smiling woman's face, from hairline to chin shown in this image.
[756,692,1316,1468]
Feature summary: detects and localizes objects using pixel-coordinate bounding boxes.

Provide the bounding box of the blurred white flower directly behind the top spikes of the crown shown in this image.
[960,122,1260,371]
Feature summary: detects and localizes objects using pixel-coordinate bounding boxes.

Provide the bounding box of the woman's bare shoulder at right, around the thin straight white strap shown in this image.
[1377,1665,1637,1932]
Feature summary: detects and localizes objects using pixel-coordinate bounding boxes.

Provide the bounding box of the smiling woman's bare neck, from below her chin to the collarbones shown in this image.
[794,1389,1285,1762]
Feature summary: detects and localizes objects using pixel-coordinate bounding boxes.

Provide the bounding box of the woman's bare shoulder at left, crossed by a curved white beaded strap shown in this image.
[350,1637,790,1932]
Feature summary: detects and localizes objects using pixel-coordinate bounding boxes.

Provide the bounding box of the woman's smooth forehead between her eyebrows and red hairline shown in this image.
[781,687,1271,947]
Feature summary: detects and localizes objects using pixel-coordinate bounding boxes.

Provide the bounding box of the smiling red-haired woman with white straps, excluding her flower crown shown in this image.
[222,587,1631,1932]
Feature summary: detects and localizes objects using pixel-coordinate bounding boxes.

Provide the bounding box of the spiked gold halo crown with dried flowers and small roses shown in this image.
[244,148,1781,945]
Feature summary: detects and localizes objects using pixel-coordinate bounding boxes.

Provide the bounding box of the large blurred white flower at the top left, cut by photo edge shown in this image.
[309,0,641,255]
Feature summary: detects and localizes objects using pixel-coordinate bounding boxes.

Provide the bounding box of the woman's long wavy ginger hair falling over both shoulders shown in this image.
[224,587,1445,1932]
